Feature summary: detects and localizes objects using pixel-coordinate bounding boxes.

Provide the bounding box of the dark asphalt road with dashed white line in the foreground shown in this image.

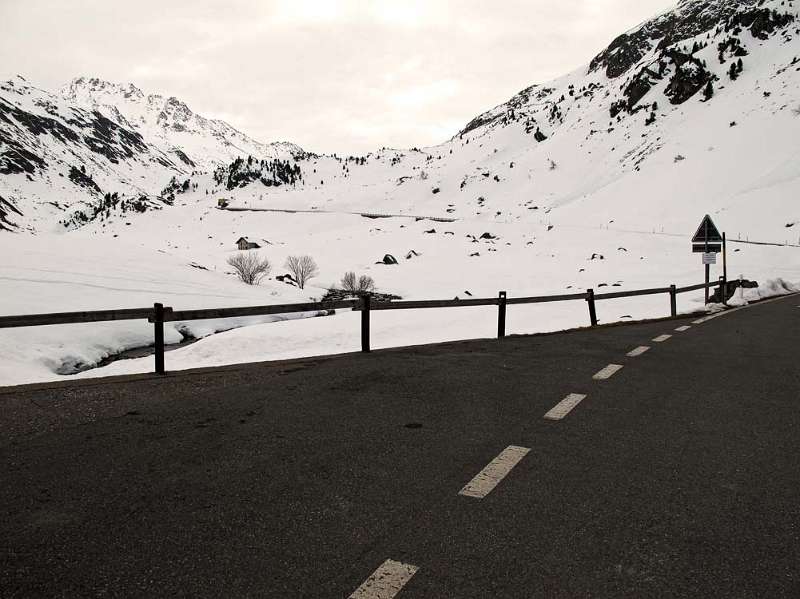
[0,296,800,599]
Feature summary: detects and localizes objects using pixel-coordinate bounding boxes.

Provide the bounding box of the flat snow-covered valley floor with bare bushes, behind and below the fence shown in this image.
[0,200,800,385]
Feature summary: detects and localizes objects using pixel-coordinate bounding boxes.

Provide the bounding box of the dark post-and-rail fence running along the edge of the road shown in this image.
[0,278,727,374]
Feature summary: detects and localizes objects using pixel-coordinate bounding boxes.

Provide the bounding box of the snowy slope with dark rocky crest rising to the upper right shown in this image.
[200,0,800,240]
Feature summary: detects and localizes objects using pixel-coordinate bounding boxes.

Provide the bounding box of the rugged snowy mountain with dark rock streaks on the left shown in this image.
[0,76,304,231]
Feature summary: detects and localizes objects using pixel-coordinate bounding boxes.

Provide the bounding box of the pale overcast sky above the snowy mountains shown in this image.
[0,0,676,154]
